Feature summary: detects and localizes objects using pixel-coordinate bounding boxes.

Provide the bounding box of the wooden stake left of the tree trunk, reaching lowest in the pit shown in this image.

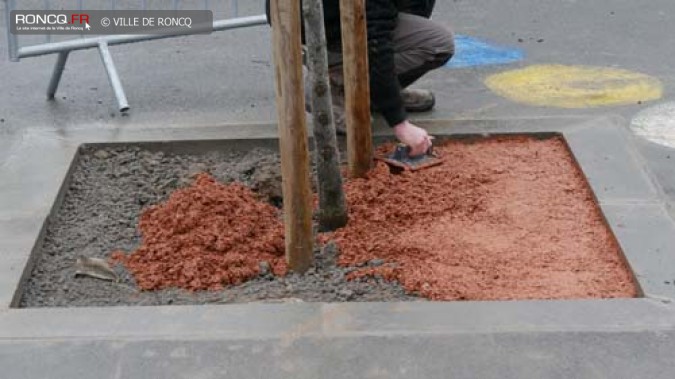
[270,0,314,273]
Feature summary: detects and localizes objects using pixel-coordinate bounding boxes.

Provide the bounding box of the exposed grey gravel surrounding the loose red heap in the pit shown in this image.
[20,145,423,307]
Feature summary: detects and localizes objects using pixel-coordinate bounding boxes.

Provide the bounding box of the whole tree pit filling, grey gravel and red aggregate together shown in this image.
[21,135,638,307]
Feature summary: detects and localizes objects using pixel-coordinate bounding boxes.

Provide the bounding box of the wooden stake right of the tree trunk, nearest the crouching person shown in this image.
[340,0,373,177]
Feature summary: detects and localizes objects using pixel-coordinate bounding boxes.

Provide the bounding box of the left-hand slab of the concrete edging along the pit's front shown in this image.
[0,303,323,340]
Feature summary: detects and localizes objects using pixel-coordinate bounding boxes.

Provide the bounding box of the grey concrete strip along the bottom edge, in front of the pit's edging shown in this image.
[0,330,675,379]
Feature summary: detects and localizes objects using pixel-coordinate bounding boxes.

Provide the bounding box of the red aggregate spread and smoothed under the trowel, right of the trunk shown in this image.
[321,137,637,300]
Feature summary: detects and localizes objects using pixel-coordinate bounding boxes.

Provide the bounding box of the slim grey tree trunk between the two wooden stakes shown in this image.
[303,0,347,231]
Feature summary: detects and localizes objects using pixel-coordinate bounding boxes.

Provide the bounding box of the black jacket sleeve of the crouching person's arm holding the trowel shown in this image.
[366,0,407,126]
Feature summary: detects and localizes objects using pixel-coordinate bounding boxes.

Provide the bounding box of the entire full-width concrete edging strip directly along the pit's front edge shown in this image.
[0,299,675,343]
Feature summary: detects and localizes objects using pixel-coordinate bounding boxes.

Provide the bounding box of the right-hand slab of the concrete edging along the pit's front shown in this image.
[324,299,675,335]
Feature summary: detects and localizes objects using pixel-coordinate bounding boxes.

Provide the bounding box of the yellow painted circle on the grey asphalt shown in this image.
[485,65,663,108]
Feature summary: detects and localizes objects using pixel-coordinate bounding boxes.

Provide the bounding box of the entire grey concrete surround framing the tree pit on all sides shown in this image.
[0,116,675,378]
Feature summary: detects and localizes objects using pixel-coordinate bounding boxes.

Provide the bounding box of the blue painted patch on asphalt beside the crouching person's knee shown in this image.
[445,35,525,68]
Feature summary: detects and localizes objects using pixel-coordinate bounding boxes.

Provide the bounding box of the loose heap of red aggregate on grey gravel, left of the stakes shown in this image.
[112,174,286,290]
